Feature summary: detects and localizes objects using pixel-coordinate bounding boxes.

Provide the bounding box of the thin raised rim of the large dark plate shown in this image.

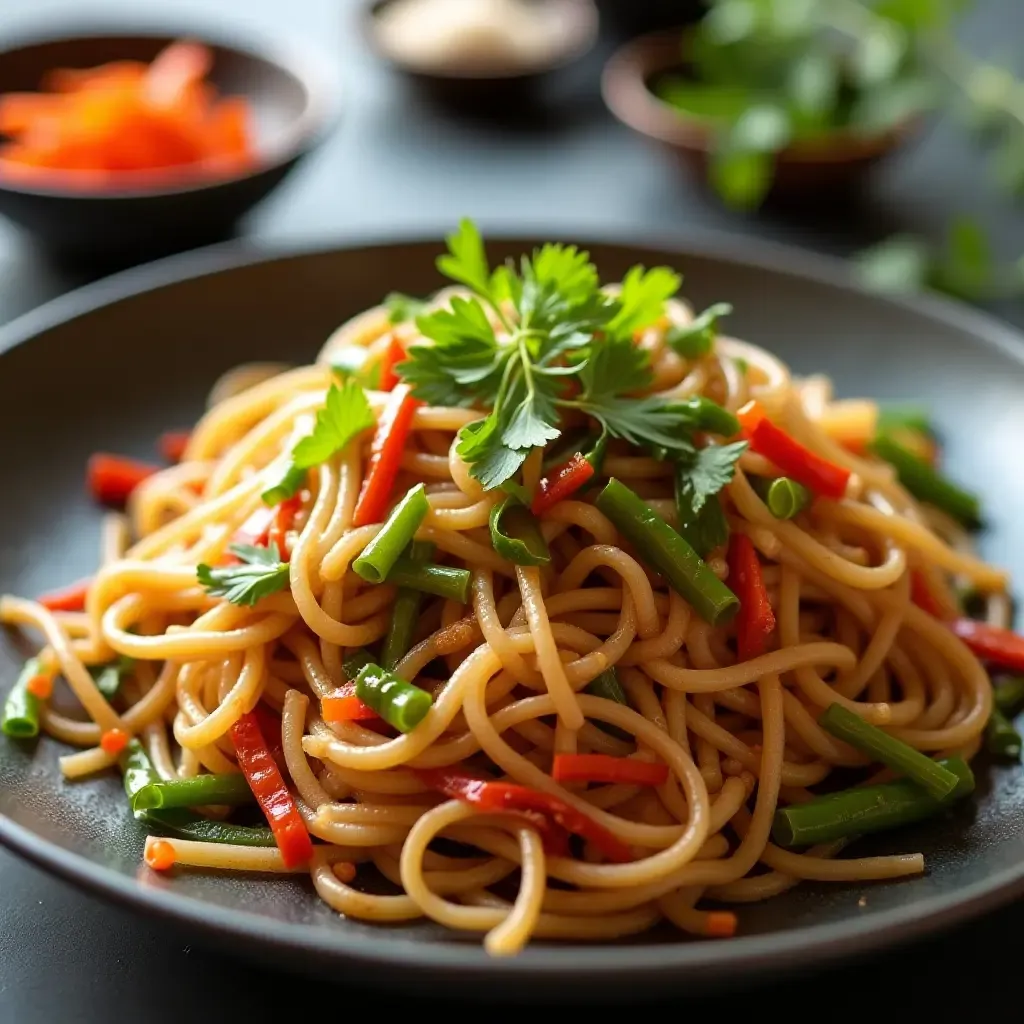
[6,222,1024,997]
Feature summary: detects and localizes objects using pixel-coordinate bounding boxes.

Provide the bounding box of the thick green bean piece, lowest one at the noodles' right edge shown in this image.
[771,758,974,847]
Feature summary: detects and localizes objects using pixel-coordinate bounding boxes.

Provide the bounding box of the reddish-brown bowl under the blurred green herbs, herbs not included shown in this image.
[601,28,919,203]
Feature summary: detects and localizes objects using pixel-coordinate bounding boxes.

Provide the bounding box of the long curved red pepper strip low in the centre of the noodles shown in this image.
[416,768,633,863]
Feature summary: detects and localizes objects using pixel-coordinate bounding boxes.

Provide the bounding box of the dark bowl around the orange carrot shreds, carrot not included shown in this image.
[0,30,338,263]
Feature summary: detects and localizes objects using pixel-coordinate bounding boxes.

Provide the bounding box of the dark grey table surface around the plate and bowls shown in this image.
[0,0,1024,1024]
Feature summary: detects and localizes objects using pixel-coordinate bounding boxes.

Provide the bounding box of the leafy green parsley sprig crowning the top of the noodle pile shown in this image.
[397,220,724,488]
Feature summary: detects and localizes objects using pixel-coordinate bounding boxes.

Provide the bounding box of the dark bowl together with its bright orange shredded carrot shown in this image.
[0,33,337,259]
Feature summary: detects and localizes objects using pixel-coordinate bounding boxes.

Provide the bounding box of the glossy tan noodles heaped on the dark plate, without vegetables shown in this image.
[2,282,1008,954]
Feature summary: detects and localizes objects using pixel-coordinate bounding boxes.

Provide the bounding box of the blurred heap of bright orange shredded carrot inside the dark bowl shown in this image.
[0,42,255,187]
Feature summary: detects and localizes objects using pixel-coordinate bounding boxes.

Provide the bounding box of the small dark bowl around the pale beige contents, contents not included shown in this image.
[362,0,600,114]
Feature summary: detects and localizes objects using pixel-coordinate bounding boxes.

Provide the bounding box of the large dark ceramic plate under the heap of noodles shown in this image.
[0,238,1024,998]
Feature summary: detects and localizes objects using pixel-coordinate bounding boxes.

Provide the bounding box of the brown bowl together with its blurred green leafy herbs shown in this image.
[602,0,935,208]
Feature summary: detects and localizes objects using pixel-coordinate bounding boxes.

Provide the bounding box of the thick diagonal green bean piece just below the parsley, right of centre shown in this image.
[596,477,739,626]
